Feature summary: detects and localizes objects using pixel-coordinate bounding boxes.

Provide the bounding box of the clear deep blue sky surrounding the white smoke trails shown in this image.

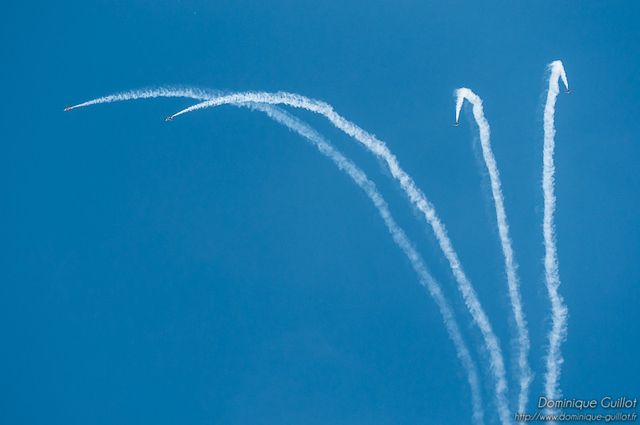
[0,1,640,424]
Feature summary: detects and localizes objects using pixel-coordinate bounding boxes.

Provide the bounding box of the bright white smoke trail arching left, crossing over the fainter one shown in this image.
[167,92,511,424]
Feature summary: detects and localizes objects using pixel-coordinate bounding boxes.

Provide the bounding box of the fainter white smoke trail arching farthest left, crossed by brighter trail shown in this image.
[66,88,484,425]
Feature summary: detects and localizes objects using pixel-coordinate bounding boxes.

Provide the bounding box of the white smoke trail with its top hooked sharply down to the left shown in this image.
[456,88,532,412]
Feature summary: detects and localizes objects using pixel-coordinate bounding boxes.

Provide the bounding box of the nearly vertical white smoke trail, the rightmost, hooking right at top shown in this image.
[542,60,569,399]
